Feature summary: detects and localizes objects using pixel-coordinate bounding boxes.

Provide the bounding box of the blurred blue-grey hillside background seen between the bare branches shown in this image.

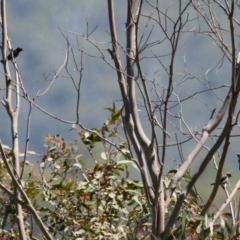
[0,0,239,206]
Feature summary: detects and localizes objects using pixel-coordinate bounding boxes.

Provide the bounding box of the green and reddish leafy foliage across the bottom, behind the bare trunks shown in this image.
[0,106,238,239]
